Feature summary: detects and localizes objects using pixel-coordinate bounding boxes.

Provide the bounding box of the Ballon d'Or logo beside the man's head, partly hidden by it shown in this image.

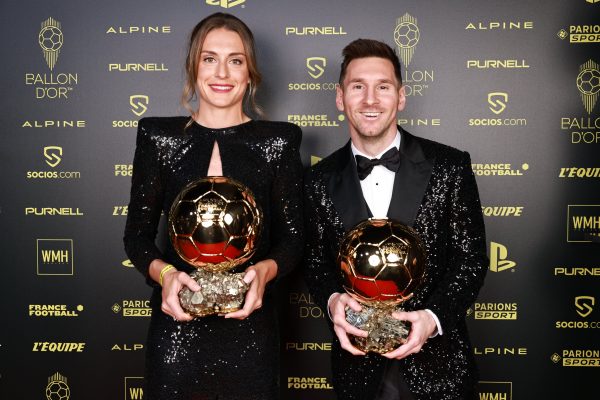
[392,13,435,97]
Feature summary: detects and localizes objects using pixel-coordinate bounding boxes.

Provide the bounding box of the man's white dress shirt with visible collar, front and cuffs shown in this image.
[327,131,443,337]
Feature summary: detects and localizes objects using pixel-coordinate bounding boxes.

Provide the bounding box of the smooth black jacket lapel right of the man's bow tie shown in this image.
[388,127,433,226]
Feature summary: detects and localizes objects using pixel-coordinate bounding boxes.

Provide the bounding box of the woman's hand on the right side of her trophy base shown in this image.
[225,259,277,319]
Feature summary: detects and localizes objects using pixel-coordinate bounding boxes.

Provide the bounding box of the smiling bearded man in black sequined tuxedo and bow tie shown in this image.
[305,39,488,400]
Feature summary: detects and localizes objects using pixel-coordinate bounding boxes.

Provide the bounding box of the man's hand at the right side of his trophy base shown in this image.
[382,310,437,360]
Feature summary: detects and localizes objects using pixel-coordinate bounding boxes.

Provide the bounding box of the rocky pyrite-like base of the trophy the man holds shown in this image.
[346,304,410,354]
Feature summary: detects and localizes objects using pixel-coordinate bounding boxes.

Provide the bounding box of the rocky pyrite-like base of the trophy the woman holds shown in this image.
[179,269,248,317]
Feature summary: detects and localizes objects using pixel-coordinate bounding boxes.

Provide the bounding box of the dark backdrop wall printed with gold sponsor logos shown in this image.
[0,0,600,400]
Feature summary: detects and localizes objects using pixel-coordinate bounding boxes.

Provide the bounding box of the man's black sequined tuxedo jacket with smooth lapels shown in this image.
[304,127,488,400]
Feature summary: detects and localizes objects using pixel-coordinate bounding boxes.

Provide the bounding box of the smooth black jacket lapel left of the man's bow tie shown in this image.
[327,141,369,232]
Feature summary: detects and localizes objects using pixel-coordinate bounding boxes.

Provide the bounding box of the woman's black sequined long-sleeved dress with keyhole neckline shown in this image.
[124,117,303,400]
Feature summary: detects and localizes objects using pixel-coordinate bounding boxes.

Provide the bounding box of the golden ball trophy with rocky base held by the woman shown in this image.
[168,176,262,317]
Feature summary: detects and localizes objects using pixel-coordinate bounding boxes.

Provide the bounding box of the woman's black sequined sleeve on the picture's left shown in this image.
[123,119,163,286]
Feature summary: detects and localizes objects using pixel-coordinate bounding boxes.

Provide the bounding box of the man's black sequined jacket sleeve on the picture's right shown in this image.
[424,152,488,331]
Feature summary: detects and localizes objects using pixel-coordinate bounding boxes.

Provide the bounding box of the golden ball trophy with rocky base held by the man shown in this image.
[338,219,425,354]
